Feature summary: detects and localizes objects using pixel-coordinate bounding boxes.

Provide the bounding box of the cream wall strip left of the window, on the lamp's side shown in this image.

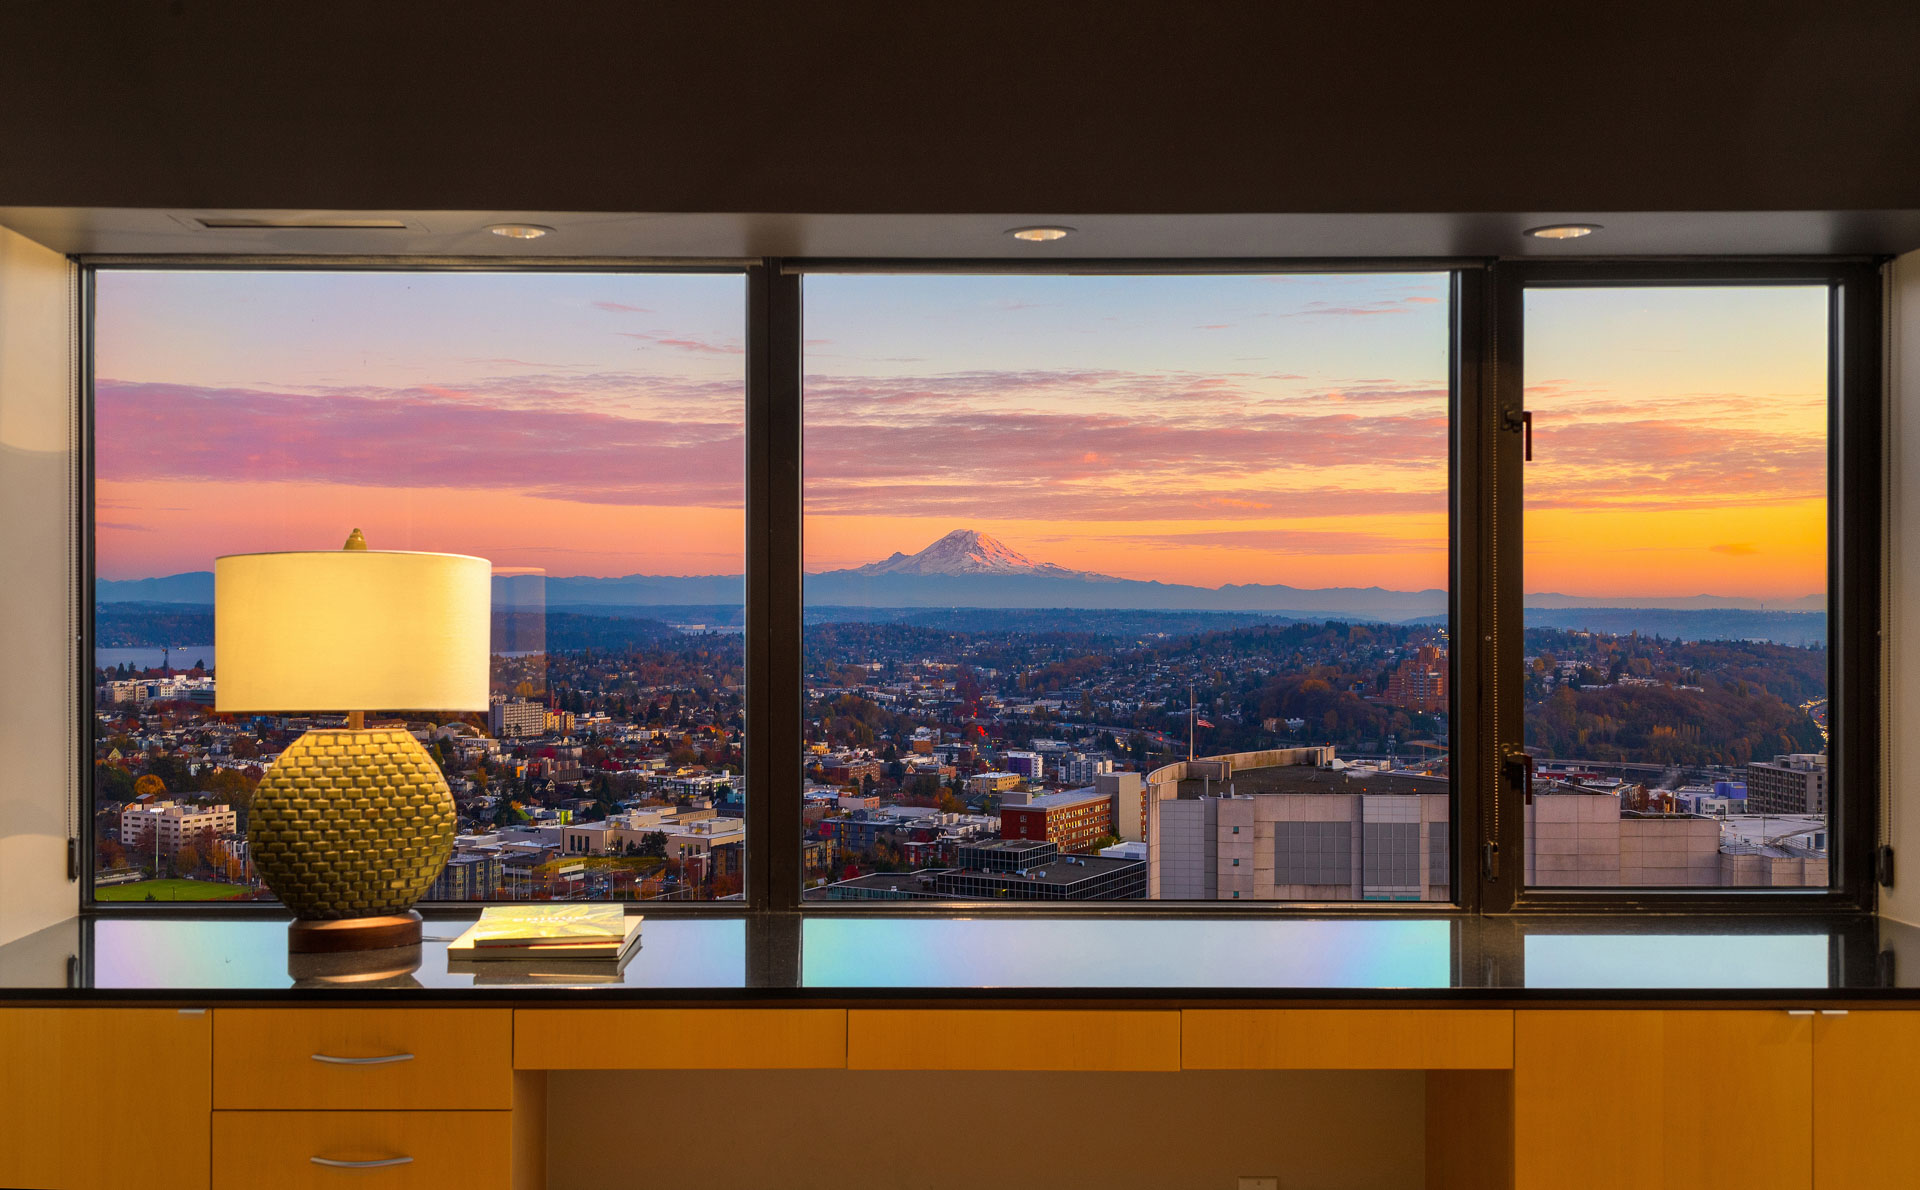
[0,228,79,942]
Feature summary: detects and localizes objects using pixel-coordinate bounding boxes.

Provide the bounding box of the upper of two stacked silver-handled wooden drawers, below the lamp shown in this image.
[213,1008,513,1109]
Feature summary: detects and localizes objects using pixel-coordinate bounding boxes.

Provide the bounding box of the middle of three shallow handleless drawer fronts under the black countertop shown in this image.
[847,1008,1181,1071]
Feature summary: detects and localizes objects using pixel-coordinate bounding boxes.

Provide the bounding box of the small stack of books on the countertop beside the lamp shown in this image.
[447,904,641,985]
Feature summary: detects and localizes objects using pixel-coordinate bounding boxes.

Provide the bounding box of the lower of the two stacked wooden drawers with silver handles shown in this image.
[213,1111,513,1190]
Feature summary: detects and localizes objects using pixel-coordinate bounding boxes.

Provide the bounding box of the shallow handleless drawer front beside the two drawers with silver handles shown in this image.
[513,1008,847,1071]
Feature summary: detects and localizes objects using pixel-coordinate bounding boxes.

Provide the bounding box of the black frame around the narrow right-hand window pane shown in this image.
[1480,257,1885,914]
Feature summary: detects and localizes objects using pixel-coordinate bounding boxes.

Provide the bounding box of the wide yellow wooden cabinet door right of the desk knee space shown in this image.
[1513,1010,1812,1190]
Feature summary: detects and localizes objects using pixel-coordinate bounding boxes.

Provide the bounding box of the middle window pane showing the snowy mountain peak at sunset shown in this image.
[803,274,1452,900]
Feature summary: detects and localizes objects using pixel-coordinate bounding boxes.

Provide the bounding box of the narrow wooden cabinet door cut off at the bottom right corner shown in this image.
[1812,1012,1920,1190]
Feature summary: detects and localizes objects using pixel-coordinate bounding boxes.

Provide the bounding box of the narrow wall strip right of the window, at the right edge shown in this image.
[1880,251,1920,925]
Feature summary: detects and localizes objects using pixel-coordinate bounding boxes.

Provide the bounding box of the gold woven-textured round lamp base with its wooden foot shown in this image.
[246,727,455,950]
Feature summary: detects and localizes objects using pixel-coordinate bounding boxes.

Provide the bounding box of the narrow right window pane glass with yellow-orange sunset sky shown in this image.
[1523,286,1830,887]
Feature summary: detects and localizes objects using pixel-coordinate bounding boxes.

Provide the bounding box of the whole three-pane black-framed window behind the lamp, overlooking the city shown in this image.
[83,261,1882,912]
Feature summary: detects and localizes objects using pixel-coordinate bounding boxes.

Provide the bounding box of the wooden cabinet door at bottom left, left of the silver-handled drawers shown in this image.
[0,1008,213,1190]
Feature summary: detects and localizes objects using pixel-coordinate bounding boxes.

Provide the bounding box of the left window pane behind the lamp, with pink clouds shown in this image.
[94,271,745,900]
